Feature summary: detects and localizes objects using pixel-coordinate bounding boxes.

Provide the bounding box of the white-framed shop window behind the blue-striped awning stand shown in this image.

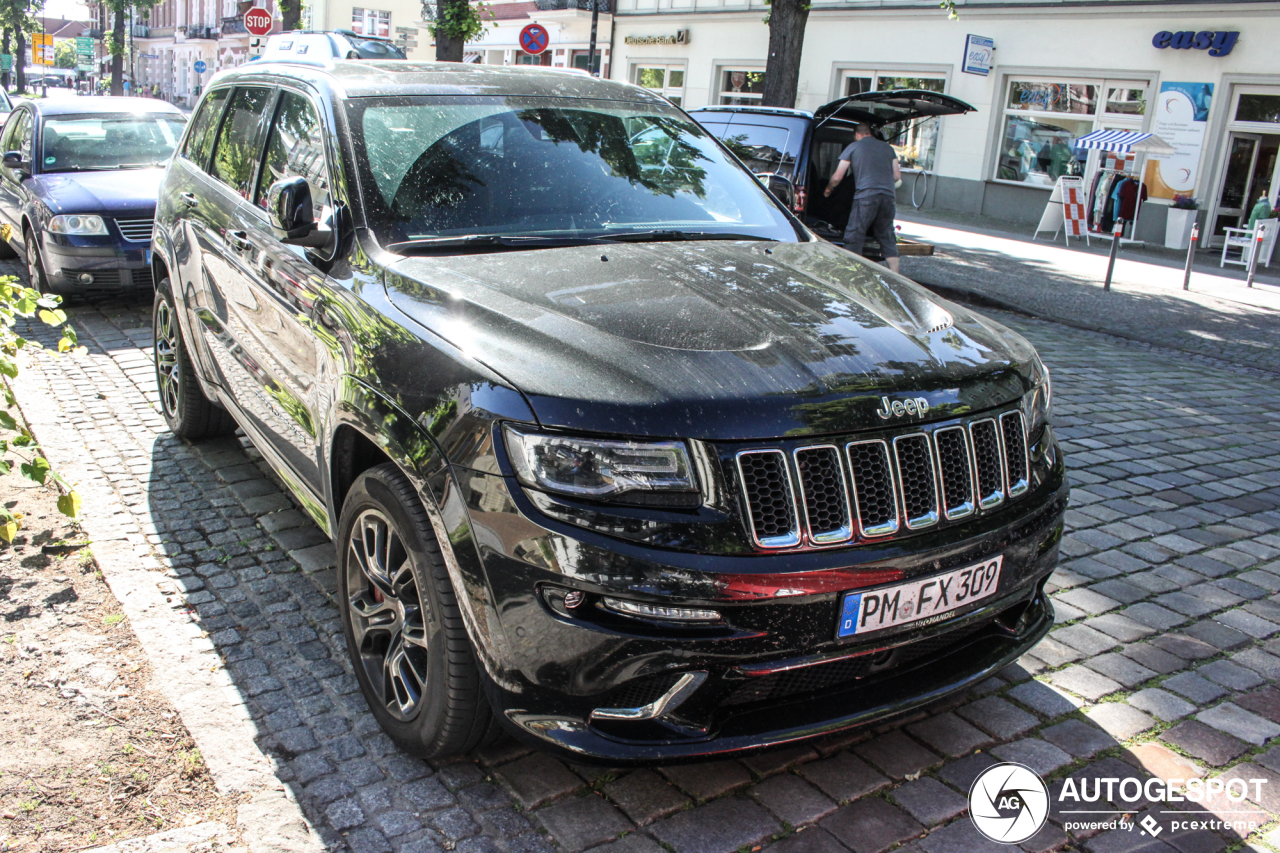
[995,78,1149,187]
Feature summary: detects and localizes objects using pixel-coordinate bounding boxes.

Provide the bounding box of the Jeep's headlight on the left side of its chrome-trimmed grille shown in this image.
[506,427,698,506]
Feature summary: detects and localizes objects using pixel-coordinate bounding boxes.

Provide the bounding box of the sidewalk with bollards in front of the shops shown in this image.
[899,211,1280,373]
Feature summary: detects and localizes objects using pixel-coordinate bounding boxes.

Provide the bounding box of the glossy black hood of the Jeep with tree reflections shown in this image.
[387,241,1034,439]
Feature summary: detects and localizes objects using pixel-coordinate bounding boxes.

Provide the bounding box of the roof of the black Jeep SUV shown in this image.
[210,59,667,104]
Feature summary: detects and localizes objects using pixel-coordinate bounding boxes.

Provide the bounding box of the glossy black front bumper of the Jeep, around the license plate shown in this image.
[458,462,1068,765]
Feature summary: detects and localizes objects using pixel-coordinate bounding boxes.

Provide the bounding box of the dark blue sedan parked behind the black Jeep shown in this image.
[0,97,187,296]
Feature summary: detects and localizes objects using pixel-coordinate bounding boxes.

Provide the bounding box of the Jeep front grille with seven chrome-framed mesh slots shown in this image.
[735,410,1030,548]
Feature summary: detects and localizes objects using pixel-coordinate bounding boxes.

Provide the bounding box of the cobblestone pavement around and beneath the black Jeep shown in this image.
[7,274,1280,853]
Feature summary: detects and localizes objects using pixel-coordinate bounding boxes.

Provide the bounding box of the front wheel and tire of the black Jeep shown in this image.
[337,462,499,758]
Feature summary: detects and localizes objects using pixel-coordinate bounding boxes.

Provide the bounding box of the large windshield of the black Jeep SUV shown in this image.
[348,96,797,245]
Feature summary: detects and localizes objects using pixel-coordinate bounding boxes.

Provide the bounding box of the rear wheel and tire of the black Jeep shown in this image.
[151,278,236,439]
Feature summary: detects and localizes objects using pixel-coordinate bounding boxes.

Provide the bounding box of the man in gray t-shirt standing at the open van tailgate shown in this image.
[823,124,902,273]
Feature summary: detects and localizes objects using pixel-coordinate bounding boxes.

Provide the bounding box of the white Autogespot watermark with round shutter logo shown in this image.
[969,762,1270,844]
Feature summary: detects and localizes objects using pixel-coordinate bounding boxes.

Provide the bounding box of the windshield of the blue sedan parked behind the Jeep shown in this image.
[40,113,187,172]
